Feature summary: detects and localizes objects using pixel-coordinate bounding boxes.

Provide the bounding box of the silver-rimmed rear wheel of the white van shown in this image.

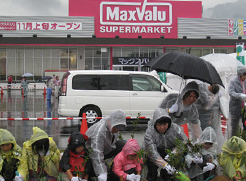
[82,106,102,127]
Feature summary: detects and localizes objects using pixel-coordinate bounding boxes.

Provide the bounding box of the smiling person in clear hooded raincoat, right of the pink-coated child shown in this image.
[144,108,187,181]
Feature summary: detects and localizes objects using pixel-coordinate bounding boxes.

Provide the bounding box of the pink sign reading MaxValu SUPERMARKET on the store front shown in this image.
[69,0,202,38]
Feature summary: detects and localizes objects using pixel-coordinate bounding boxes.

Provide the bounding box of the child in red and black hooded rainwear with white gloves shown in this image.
[60,131,88,181]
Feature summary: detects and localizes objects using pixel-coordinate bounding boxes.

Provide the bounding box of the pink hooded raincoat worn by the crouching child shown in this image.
[113,138,143,180]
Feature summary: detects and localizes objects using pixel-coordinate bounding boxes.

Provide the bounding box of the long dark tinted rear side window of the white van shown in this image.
[72,75,129,90]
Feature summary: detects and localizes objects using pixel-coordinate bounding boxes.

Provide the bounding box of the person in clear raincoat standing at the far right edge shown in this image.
[227,67,246,138]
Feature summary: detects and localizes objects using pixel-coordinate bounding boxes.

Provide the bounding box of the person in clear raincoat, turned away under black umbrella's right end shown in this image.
[195,83,228,152]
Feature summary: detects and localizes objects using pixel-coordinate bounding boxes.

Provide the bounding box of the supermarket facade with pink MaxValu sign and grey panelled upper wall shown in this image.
[0,0,244,81]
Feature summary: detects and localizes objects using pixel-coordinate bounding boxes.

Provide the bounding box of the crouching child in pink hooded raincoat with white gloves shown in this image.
[113,138,142,181]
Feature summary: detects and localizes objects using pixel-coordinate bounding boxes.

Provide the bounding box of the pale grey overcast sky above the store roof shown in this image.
[0,0,240,16]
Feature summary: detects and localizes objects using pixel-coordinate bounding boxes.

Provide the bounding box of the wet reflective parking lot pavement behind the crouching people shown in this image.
[0,89,147,149]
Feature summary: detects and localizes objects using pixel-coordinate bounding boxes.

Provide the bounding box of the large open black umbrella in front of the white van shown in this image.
[145,52,224,87]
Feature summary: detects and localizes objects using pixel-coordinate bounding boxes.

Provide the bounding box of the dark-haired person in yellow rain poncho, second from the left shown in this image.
[15,127,60,181]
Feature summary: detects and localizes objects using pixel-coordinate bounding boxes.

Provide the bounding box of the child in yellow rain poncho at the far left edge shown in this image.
[0,129,21,181]
